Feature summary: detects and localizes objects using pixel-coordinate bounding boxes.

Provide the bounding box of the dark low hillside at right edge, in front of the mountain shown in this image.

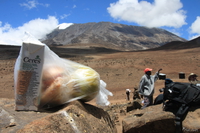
[155,36,200,50]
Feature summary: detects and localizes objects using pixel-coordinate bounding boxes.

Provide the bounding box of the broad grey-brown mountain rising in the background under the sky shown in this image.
[43,22,186,51]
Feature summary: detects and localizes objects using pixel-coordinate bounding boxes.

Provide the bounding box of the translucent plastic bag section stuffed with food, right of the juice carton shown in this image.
[40,46,112,107]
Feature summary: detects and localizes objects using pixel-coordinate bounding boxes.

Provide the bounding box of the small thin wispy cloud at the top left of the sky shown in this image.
[20,0,49,9]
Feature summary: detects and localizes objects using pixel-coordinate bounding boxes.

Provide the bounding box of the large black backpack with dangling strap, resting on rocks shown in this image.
[163,82,200,133]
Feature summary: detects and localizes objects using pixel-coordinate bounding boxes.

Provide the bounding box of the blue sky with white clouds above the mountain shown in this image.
[0,0,200,45]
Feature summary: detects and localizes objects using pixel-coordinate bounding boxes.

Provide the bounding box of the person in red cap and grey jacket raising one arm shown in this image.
[139,68,162,109]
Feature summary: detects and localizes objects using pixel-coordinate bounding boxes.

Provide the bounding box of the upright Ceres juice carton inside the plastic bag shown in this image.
[14,42,45,111]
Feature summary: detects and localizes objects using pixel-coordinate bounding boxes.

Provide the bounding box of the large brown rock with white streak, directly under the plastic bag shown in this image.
[17,101,117,133]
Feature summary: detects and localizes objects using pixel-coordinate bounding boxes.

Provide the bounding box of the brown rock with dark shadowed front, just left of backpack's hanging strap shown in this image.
[122,105,175,133]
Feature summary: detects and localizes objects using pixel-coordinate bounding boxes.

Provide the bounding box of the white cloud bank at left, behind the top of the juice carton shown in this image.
[0,16,58,45]
